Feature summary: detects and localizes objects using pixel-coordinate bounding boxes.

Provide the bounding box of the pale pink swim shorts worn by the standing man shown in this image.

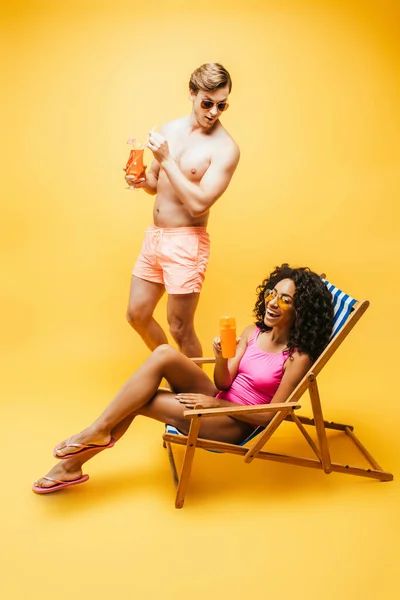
[132,225,210,294]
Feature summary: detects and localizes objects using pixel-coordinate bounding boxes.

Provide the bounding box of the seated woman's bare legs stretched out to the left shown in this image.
[36,345,250,487]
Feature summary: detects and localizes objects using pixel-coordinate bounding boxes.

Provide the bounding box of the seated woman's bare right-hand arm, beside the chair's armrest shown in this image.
[233,352,312,427]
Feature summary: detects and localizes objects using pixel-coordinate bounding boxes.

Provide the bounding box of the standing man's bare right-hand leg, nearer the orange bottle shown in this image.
[167,294,203,357]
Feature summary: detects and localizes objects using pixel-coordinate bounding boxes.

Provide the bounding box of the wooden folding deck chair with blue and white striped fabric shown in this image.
[163,276,393,508]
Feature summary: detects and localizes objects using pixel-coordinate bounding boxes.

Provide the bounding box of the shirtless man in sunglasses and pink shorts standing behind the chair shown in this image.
[126,63,239,357]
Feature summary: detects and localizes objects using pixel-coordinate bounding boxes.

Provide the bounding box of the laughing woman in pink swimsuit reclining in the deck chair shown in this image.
[32,264,333,494]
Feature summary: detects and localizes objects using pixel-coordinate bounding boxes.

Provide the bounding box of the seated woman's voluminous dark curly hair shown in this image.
[253,263,333,361]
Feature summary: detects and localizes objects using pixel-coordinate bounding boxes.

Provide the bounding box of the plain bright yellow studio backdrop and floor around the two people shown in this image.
[0,0,400,600]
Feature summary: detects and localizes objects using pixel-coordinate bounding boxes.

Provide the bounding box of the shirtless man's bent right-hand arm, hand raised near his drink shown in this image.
[148,133,240,217]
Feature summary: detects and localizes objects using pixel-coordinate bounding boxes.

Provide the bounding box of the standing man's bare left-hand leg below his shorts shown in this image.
[126,275,168,350]
